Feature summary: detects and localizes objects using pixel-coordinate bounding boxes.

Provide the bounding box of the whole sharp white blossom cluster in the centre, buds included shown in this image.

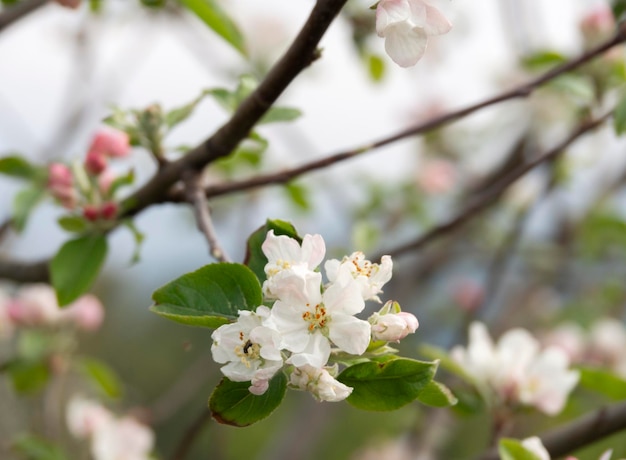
[211,231,418,401]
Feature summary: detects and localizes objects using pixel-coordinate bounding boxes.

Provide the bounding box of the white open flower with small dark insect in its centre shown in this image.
[211,306,283,395]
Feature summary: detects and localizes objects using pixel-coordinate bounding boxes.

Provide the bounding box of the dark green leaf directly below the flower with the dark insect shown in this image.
[209,372,287,427]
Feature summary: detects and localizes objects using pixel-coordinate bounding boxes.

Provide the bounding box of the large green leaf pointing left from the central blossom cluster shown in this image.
[150,263,263,328]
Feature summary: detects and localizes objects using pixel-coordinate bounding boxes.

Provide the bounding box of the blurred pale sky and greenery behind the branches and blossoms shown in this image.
[0,0,626,460]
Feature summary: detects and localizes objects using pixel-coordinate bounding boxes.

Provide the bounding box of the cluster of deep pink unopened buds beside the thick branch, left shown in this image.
[47,128,130,222]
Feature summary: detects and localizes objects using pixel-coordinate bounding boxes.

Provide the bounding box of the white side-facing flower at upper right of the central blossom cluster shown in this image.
[324,251,393,302]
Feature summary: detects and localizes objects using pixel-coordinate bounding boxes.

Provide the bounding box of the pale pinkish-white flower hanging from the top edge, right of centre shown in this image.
[376,0,452,67]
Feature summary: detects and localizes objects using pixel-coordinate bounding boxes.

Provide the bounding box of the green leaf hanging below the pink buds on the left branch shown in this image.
[50,235,107,306]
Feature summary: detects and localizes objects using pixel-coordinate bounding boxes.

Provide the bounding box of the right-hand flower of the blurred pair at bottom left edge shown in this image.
[91,417,154,460]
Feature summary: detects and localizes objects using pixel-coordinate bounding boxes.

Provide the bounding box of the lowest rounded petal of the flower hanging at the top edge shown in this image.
[385,23,428,67]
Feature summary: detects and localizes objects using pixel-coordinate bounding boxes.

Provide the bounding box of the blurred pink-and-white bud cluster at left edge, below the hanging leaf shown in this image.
[0,284,104,338]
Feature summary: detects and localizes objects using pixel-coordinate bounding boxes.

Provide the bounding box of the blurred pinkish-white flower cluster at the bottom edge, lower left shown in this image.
[66,396,154,460]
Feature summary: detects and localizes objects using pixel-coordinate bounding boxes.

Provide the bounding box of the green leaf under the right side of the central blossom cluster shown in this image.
[337,358,438,411]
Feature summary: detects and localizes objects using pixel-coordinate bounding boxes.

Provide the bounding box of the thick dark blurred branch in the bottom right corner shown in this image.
[480,401,626,460]
